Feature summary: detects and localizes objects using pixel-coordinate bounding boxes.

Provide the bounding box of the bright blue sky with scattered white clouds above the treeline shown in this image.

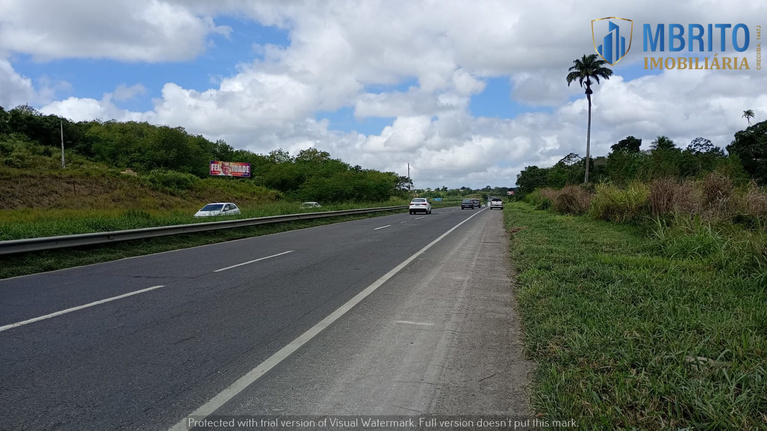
[0,0,767,187]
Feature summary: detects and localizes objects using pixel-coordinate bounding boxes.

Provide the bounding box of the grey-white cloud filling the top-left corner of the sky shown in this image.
[0,0,229,62]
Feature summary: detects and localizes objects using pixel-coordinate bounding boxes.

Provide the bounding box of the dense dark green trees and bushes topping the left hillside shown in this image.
[0,106,410,203]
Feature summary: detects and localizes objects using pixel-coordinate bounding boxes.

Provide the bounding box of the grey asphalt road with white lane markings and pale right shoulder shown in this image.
[0,208,532,430]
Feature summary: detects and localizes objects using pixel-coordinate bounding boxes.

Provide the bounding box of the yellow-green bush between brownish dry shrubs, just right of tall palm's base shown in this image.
[590,182,650,222]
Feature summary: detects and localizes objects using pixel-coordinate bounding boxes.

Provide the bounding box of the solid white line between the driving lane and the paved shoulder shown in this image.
[170,212,486,431]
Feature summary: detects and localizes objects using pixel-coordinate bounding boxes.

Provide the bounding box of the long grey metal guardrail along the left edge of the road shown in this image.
[0,205,408,255]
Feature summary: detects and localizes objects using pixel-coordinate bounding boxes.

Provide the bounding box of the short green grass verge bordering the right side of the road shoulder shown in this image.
[505,203,767,430]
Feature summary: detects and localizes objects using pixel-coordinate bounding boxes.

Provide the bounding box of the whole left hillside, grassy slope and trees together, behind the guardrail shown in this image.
[0,106,416,210]
